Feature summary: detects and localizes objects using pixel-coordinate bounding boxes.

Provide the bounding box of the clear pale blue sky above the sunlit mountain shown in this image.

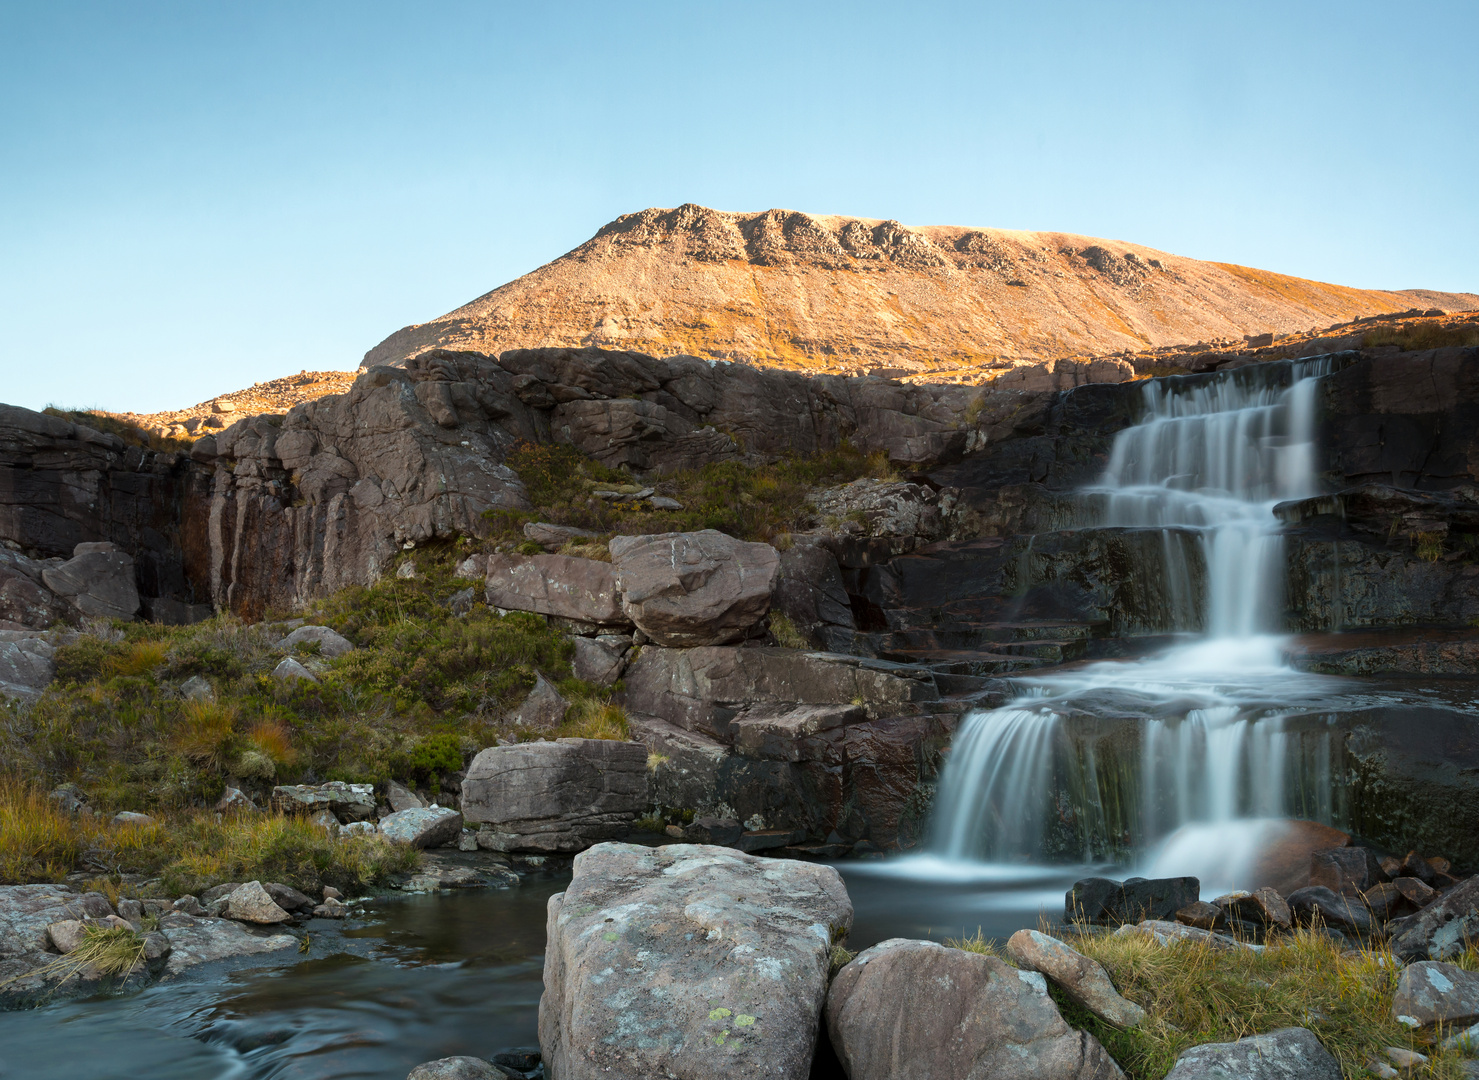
[0,0,1479,411]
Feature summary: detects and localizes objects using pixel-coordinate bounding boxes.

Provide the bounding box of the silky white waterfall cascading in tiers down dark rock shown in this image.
[932,361,1331,885]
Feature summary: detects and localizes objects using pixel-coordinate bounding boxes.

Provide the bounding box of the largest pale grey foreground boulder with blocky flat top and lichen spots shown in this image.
[540,843,856,1080]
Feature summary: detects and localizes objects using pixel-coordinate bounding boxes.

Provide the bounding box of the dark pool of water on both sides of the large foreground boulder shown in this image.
[0,858,1081,1080]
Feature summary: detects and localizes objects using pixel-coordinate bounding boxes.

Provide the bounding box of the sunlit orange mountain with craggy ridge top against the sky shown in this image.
[364,204,1479,373]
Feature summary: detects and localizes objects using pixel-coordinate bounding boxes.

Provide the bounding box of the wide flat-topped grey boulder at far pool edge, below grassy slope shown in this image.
[461,738,649,852]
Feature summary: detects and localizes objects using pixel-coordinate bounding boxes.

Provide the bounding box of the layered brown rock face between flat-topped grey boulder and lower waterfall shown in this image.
[626,645,954,846]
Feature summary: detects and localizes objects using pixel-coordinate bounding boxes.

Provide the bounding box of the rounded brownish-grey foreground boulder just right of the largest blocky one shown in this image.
[828,938,1124,1080]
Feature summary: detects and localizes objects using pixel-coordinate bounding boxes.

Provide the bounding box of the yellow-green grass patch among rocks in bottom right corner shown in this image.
[947,928,1479,1080]
